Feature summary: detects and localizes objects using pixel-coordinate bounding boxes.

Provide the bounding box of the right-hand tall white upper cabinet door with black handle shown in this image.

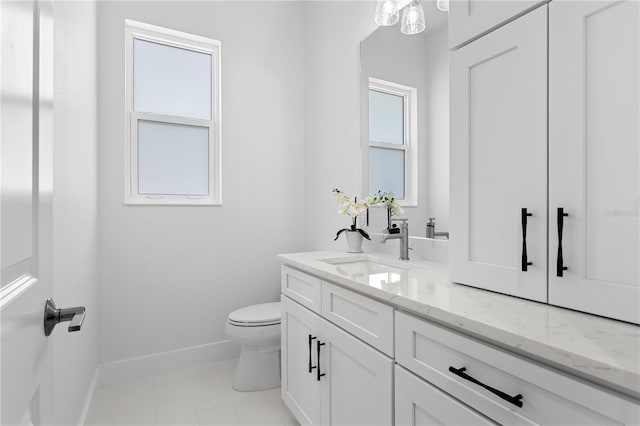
[549,1,640,323]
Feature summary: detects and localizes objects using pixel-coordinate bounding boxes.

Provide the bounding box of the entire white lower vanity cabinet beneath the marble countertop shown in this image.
[281,260,640,426]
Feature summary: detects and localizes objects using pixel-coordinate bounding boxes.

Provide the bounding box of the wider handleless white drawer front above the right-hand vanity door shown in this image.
[322,281,393,357]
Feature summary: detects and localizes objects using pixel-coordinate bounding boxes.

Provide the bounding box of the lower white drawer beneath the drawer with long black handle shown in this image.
[395,365,496,426]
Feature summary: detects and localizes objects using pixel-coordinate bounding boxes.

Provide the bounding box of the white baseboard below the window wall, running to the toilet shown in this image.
[98,340,240,387]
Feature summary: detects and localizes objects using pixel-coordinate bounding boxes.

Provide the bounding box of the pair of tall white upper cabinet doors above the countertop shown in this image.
[450,0,640,324]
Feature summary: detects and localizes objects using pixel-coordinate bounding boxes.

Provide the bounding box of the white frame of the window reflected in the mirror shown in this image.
[363,77,418,207]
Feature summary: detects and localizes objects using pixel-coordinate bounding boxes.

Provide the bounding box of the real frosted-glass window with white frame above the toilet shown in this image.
[125,20,222,205]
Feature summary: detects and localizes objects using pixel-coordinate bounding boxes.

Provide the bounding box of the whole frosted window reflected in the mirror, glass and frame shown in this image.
[369,78,418,205]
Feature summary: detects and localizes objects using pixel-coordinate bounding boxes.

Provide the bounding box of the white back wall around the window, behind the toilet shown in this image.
[98,2,305,362]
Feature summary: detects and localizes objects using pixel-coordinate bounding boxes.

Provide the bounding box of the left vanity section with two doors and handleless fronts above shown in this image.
[282,267,393,426]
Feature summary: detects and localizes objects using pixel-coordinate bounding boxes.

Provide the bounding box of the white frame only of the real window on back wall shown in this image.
[125,19,222,206]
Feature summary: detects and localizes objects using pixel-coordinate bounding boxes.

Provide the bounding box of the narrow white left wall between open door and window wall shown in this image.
[52,1,98,425]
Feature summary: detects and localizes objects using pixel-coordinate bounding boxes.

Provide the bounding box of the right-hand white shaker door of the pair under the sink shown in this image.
[318,320,393,426]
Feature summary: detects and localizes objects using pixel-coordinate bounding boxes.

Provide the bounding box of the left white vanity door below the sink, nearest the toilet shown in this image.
[281,296,320,425]
